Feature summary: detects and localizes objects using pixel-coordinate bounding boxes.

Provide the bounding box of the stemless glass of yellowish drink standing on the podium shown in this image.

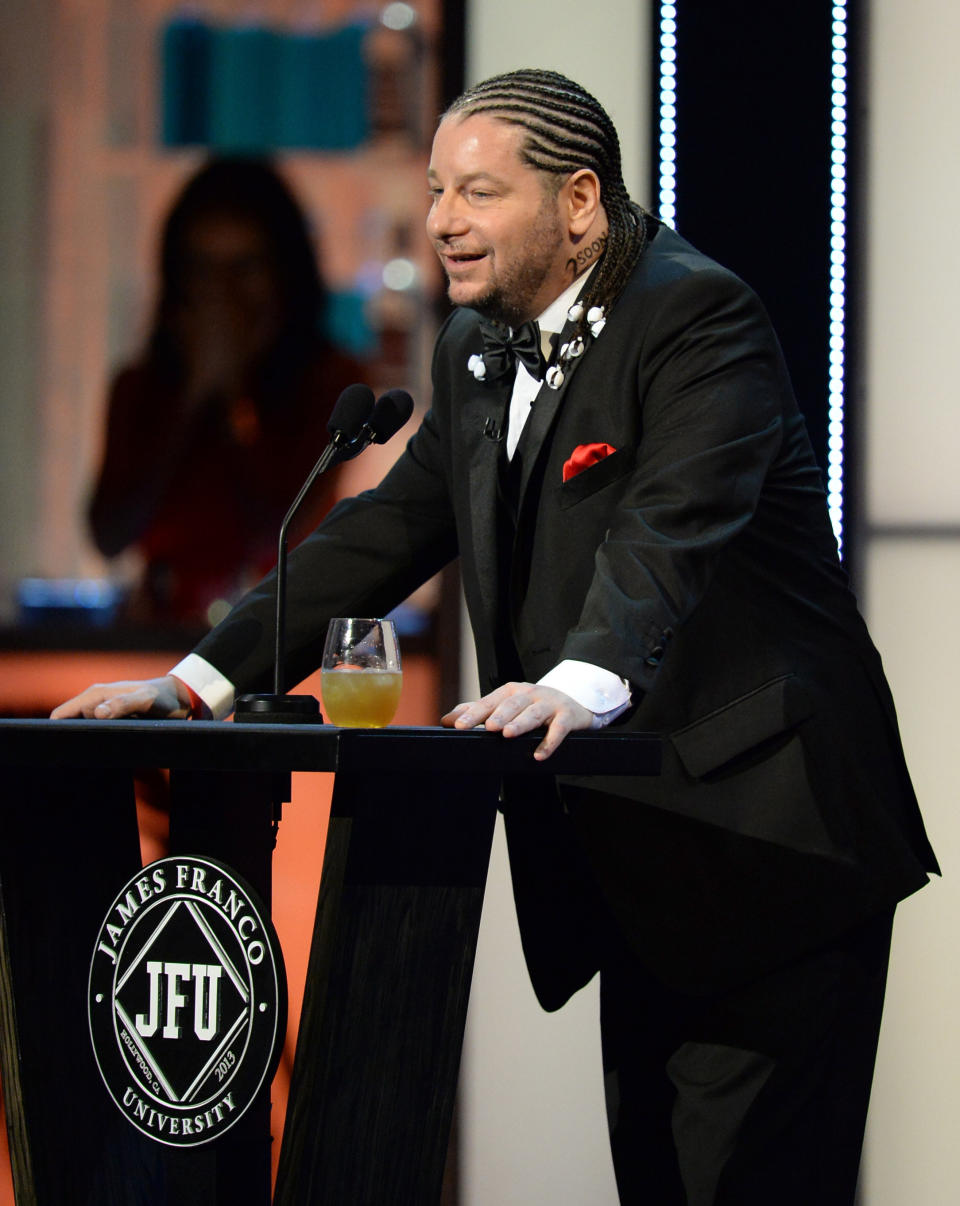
[320,619,402,728]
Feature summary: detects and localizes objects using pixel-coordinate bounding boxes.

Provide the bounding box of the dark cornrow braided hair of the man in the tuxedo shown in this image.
[443,68,648,327]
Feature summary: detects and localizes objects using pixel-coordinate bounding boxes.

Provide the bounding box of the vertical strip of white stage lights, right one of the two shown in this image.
[826,4,847,554]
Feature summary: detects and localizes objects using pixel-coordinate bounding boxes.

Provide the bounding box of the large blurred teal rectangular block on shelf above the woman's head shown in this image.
[159,16,370,153]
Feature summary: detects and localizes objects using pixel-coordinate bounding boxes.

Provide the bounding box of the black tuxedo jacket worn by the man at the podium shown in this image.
[195,228,936,1007]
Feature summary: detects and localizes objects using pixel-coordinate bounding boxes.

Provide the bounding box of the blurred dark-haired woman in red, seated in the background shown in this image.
[89,158,364,626]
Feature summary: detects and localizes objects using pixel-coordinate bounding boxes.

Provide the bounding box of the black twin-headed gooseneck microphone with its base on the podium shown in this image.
[234,385,414,724]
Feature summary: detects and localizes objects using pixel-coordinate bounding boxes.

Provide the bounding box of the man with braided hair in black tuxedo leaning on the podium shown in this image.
[54,71,936,1206]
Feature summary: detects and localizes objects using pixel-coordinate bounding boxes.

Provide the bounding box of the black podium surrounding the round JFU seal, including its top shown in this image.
[0,720,660,1206]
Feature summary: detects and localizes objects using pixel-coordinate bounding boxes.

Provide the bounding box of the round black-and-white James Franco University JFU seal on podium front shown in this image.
[88,855,287,1147]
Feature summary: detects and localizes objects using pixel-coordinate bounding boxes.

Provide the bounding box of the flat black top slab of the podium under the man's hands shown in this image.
[0,720,661,775]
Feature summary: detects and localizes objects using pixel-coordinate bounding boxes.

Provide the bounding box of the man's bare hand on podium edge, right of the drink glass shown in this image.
[440,683,593,762]
